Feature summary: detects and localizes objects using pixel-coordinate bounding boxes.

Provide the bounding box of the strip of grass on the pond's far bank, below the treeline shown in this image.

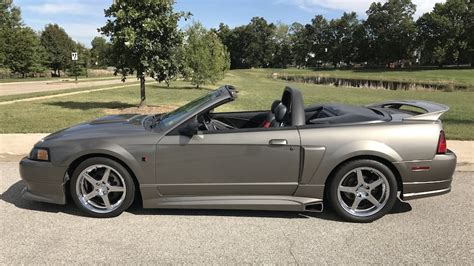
[273,68,474,88]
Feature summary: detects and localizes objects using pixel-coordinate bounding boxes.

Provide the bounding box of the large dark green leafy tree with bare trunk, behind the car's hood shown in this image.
[100,0,190,106]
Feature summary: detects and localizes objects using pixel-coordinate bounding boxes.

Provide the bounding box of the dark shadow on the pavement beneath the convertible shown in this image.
[0,181,412,222]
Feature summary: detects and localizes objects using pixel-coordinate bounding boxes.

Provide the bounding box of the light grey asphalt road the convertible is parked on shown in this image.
[0,163,474,265]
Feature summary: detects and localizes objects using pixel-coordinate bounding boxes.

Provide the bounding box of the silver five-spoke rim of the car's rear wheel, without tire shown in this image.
[337,167,390,217]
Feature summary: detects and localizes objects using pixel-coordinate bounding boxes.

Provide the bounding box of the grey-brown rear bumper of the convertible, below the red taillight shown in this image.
[395,150,457,200]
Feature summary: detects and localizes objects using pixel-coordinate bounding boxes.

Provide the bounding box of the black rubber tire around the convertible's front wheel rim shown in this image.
[70,157,135,218]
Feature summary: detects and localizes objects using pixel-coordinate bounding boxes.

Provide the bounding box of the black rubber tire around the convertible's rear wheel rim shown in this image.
[326,159,398,223]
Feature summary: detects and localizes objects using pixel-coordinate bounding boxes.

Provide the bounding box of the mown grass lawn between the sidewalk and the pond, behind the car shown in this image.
[0,69,474,140]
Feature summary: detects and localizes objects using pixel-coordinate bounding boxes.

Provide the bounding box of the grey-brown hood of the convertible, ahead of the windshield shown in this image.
[43,114,148,141]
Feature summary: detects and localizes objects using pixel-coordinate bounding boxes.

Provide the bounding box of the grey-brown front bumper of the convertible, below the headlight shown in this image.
[20,157,67,204]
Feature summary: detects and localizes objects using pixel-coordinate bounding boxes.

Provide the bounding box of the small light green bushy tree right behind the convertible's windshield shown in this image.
[185,22,230,88]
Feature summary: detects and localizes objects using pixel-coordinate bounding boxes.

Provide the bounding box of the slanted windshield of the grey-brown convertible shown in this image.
[158,90,221,129]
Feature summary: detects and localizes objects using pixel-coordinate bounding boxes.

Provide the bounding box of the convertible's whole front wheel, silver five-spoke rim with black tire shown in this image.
[70,158,135,218]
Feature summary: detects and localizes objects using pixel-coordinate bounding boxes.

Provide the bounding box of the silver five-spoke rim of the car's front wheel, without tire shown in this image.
[76,164,126,213]
